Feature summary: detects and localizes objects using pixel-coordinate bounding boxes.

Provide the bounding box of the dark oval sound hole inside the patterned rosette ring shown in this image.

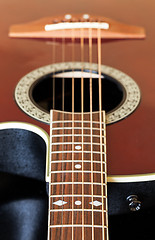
[30,72,125,112]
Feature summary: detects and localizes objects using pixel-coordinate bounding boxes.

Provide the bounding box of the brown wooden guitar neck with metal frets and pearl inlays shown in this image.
[48,110,108,240]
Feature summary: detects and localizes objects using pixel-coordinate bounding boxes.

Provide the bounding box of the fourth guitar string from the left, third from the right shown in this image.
[81,28,84,240]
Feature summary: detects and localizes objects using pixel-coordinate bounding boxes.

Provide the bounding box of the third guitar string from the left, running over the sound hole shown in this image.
[72,26,75,240]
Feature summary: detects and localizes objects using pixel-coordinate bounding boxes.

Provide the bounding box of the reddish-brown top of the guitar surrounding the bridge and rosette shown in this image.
[0,1,155,178]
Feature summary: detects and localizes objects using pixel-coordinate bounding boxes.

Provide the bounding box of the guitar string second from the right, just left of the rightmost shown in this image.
[89,28,94,240]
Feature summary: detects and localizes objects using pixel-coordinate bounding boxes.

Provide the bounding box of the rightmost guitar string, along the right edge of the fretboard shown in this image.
[97,28,105,239]
